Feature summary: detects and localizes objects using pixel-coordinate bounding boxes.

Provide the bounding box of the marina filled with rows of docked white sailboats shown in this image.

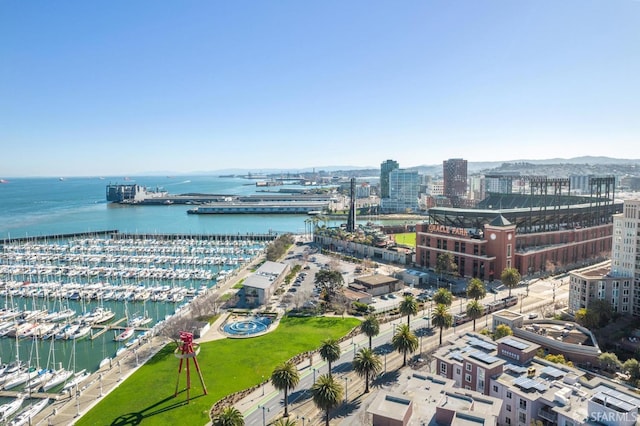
[0,233,270,411]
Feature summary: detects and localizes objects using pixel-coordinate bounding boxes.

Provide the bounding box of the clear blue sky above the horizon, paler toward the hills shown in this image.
[0,0,640,177]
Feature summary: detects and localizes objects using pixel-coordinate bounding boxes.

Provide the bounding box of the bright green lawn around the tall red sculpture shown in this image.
[76,317,360,426]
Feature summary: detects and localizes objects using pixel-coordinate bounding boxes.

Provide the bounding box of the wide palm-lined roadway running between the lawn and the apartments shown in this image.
[236,279,569,425]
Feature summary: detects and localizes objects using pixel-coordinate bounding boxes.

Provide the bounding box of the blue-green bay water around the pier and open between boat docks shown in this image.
[0,176,348,402]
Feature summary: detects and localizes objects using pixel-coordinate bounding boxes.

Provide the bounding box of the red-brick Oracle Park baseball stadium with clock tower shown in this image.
[415,176,623,281]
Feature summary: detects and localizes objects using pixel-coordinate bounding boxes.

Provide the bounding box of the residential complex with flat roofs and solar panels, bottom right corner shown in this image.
[434,333,640,426]
